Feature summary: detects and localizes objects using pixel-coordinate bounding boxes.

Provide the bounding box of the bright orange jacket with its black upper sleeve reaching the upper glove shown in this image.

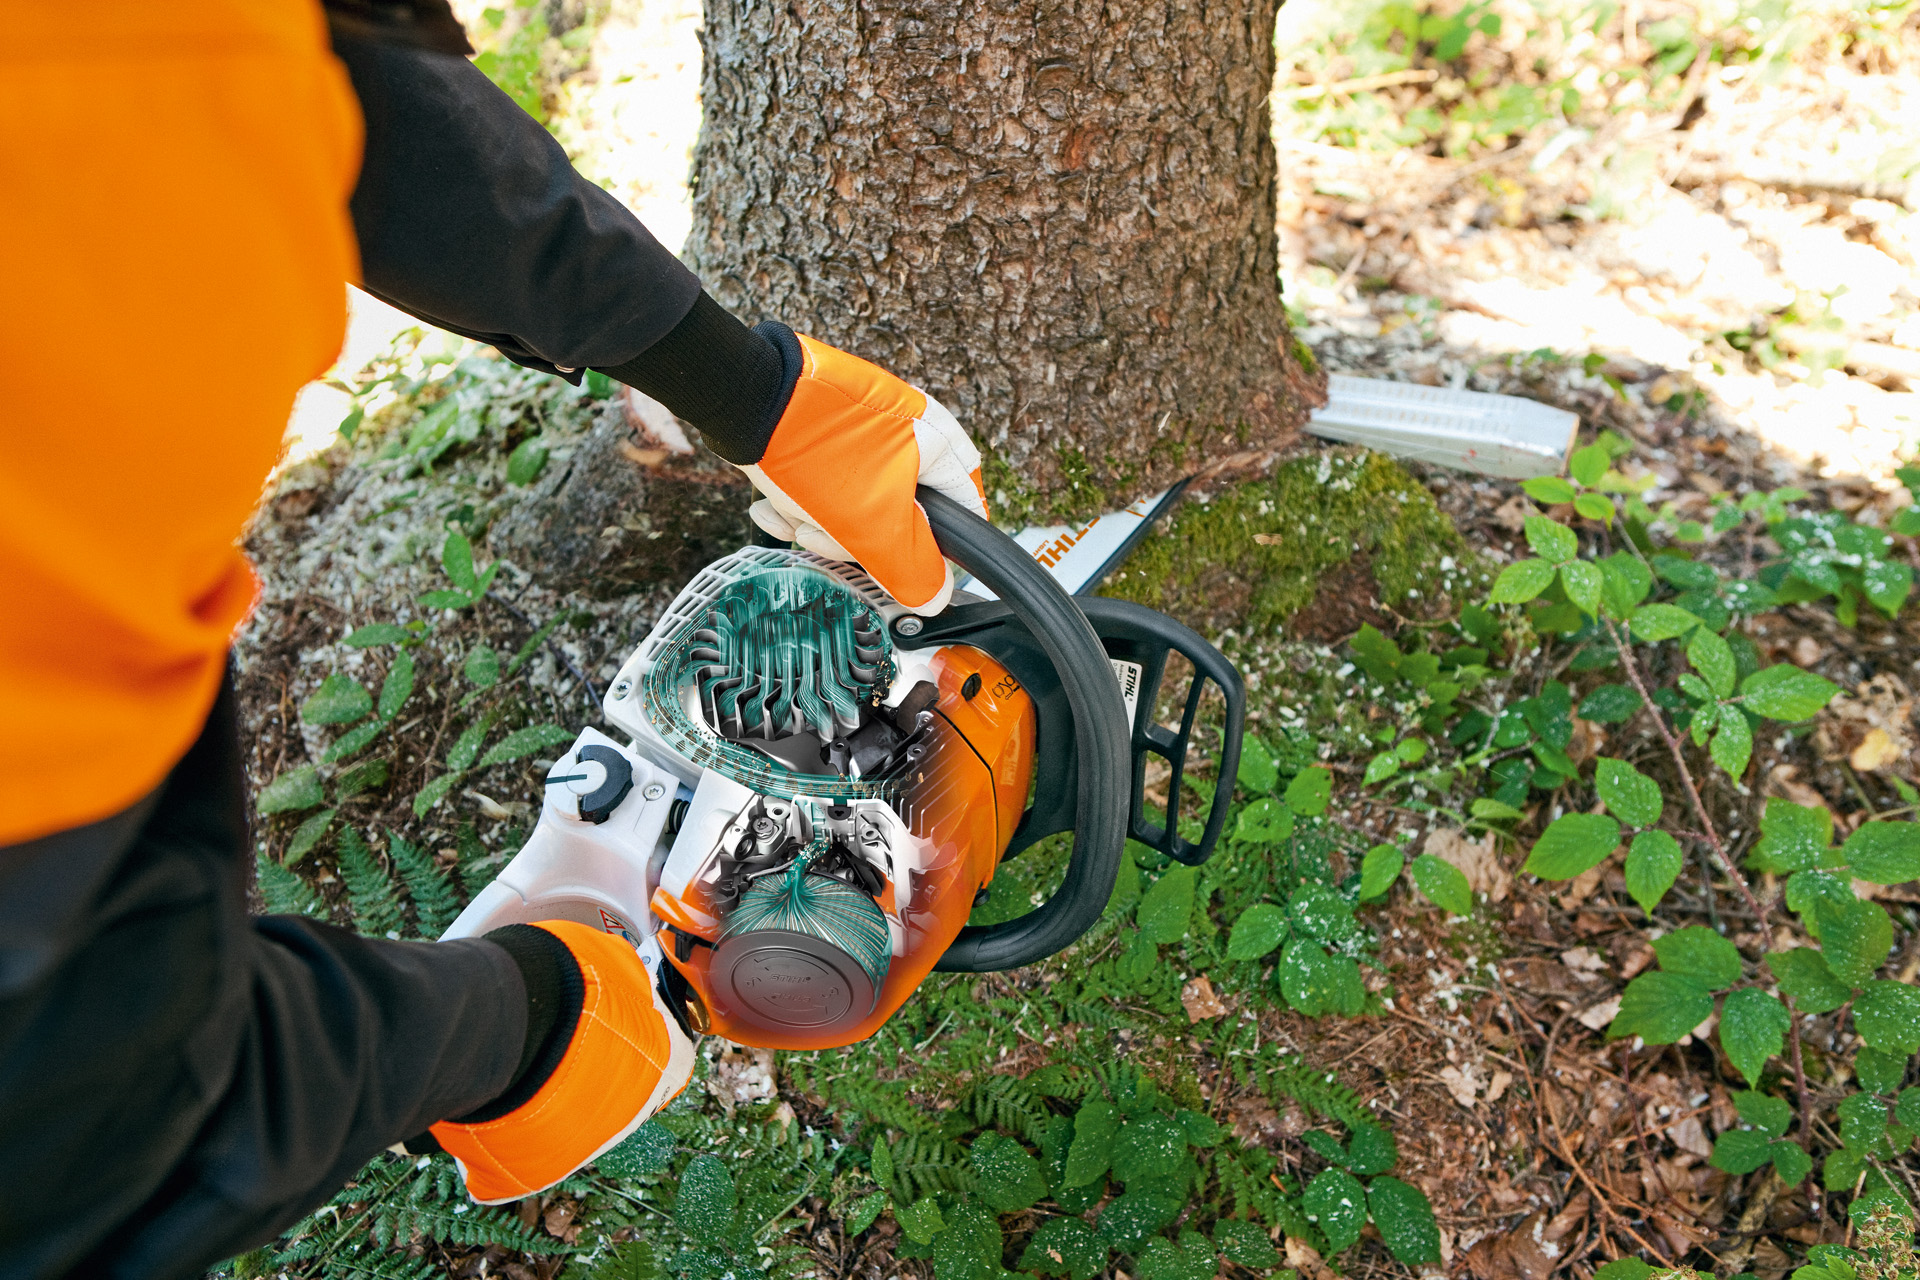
[0,0,721,848]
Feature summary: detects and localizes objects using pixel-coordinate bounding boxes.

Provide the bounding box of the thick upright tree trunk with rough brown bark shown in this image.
[687,0,1321,514]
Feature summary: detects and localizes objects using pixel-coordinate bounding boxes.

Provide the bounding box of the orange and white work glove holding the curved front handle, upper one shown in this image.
[725,324,987,614]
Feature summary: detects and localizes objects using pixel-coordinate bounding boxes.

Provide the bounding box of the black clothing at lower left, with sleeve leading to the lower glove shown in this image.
[0,685,526,1280]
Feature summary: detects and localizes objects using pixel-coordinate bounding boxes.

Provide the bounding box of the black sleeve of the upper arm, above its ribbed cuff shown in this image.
[334,21,701,378]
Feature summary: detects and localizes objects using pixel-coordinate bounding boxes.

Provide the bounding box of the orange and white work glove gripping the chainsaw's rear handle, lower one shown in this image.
[432,919,693,1205]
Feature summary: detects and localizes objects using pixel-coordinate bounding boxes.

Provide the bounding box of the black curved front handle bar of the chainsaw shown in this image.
[893,487,1133,973]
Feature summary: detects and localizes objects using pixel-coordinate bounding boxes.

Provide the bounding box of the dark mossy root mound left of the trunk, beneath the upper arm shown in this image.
[488,390,753,601]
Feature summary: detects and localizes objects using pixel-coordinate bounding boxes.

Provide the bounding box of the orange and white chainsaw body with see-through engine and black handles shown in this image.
[445,489,1246,1050]
